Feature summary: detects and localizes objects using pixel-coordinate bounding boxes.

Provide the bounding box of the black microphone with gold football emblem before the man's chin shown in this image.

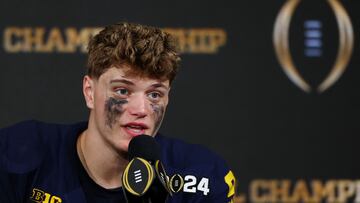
[122,135,172,203]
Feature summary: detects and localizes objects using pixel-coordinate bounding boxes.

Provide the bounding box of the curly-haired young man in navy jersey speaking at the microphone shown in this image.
[0,23,235,203]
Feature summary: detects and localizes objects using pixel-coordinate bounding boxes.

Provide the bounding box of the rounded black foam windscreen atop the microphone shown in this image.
[128,135,160,161]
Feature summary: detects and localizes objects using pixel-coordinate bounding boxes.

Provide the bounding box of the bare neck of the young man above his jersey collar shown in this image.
[77,129,128,189]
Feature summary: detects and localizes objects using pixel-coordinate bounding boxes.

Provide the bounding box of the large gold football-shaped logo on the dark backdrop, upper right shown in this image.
[273,0,354,93]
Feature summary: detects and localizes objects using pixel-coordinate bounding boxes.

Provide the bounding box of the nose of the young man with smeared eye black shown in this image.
[128,94,148,118]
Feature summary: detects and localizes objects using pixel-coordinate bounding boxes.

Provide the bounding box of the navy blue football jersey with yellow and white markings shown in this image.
[0,121,235,203]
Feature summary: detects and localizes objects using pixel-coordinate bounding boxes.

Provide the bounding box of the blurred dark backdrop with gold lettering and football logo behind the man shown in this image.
[0,0,360,202]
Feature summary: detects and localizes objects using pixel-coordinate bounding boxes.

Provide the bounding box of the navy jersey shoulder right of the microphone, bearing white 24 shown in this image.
[156,135,235,202]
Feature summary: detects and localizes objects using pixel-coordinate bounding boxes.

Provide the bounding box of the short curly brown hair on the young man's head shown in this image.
[87,22,180,83]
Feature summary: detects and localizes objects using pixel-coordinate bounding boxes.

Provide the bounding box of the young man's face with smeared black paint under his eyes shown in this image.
[83,65,170,152]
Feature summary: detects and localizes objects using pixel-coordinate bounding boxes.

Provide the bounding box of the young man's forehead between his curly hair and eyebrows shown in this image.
[99,65,170,87]
